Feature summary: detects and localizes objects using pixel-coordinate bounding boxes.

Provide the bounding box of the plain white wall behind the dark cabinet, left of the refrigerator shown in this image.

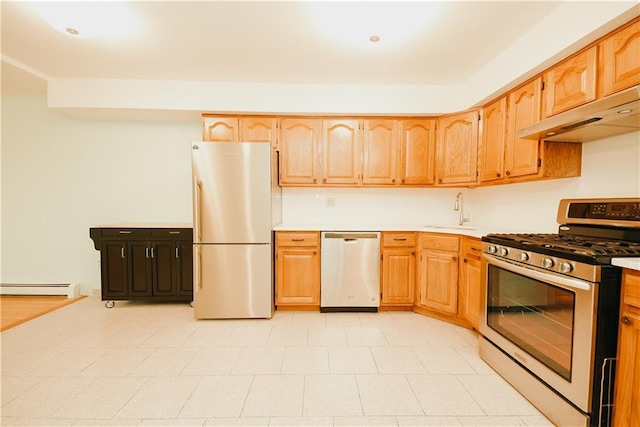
[0,96,200,293]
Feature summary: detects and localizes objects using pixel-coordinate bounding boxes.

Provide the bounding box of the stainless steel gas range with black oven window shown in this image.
[480,198,640,426]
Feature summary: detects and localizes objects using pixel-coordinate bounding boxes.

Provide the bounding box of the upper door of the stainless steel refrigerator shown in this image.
[191,142,270,243]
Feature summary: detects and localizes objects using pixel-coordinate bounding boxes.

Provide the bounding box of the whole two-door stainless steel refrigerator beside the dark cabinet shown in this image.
[191,142,282,319]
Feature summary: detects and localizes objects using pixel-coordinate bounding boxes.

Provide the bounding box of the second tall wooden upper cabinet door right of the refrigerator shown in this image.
[322,119,362,185]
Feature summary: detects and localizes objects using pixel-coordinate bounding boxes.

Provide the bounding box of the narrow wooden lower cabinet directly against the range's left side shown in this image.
[458,237,482,330]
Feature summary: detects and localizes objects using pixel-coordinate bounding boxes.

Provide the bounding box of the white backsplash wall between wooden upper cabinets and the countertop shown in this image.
[283,132,640,232]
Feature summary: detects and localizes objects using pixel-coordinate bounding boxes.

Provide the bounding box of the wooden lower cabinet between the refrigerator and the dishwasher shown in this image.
[276,231,320,310]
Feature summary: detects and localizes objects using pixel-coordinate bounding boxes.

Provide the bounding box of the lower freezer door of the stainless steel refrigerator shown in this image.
[193,244,274,319]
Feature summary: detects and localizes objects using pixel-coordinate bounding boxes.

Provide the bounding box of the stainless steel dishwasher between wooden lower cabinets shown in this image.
[320,231,380,312]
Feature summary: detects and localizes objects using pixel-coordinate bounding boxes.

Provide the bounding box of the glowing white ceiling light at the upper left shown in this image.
[30,0,139,38]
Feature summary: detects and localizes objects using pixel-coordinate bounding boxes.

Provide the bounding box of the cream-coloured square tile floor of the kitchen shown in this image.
[0,297,553,426]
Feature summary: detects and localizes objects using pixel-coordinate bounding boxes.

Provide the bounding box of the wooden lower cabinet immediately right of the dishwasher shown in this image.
[380,232,417,309]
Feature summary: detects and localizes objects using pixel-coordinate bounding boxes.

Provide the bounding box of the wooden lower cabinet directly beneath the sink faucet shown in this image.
[416,233,459,317]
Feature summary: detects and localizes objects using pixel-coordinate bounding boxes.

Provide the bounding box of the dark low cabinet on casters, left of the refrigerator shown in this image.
[89,227,193,307]
